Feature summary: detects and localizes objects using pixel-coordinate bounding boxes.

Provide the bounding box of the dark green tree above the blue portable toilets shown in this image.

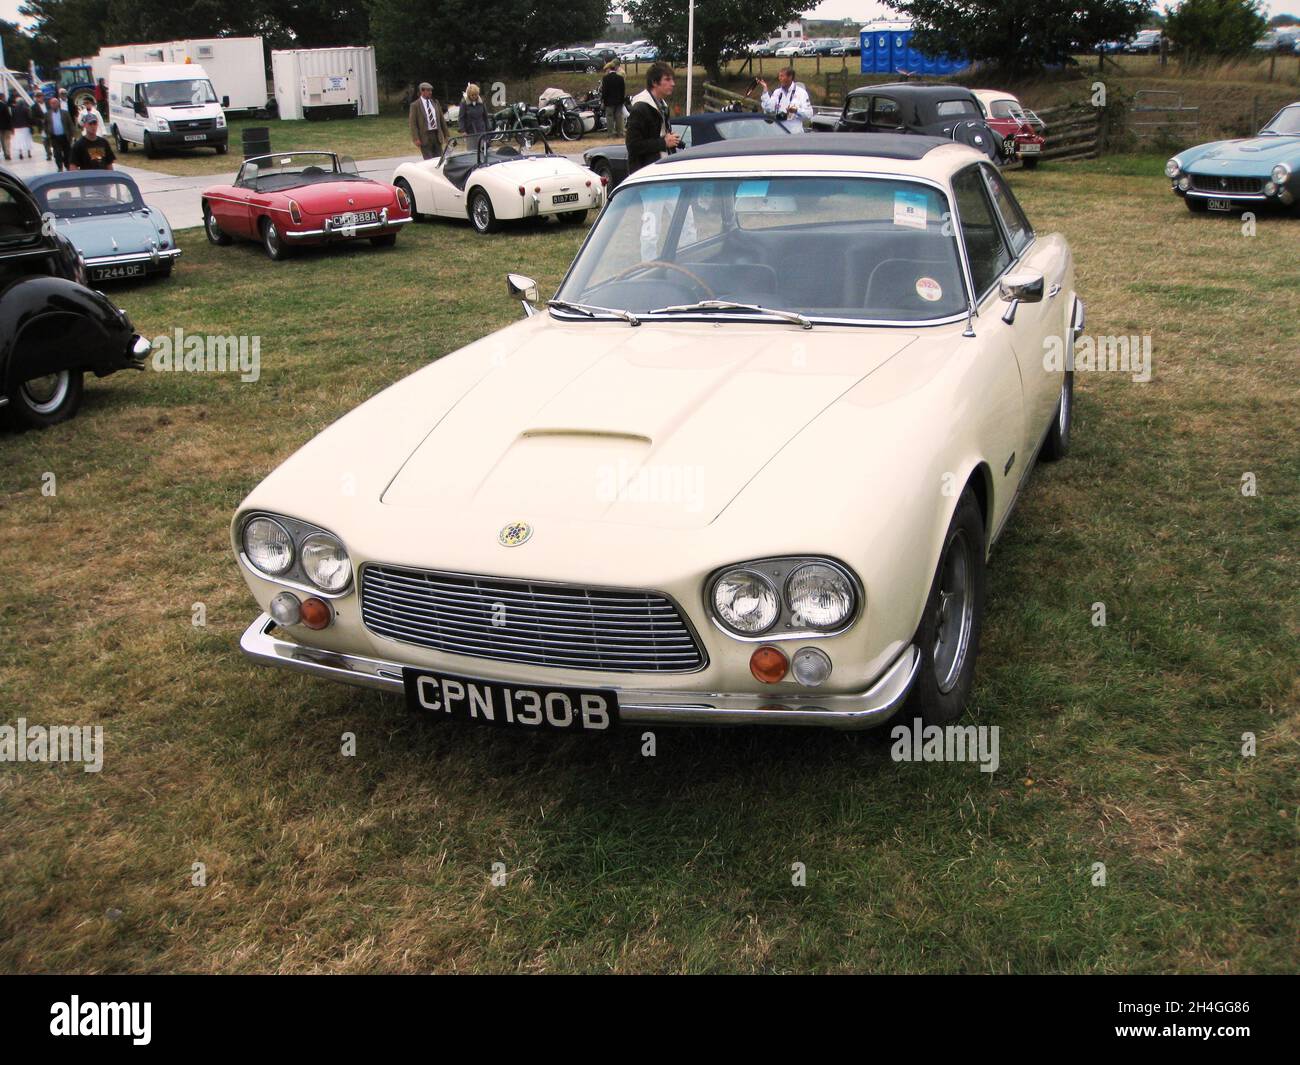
[889,0,1152,77]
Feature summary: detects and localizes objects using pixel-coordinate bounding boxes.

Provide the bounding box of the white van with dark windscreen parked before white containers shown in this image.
[108,62,230,159]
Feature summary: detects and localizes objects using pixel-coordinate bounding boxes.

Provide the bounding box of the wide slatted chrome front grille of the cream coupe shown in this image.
[361,564,705,674]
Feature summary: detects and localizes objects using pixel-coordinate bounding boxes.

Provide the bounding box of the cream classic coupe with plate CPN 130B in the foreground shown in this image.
[231,134,1083,731]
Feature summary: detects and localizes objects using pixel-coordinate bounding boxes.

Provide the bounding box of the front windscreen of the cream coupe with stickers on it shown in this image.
[558,177,966,321]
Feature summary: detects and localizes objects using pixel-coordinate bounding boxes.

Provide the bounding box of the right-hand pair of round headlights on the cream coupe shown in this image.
[705,557,861,638]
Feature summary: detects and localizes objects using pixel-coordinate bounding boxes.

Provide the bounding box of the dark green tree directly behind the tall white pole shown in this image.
[623,0,809,81]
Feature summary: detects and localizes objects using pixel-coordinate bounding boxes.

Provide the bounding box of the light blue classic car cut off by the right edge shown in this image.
[1165,100,1300,212]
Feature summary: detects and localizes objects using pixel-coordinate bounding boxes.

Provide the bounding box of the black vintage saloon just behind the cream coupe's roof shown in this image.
[809,82,1015,163]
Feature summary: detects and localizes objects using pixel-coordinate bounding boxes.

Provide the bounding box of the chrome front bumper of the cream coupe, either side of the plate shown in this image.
[239,614,920,730]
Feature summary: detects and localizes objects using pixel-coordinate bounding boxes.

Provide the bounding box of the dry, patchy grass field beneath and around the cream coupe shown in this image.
[0,156,1300,973]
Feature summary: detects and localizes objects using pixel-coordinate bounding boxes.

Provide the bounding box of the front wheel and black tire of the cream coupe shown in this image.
[904,488,984,724]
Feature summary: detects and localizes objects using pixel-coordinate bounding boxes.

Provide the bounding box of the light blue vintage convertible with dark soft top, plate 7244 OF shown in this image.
[27,170,181,283]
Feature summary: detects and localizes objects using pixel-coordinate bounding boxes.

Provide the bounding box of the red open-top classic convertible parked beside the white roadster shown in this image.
[203,152,411,259]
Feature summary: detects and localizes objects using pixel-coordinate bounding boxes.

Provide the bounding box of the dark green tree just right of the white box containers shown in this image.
[369,0,610,98]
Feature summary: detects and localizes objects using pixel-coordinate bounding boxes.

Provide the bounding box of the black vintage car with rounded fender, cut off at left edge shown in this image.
[0,169,150,429]
